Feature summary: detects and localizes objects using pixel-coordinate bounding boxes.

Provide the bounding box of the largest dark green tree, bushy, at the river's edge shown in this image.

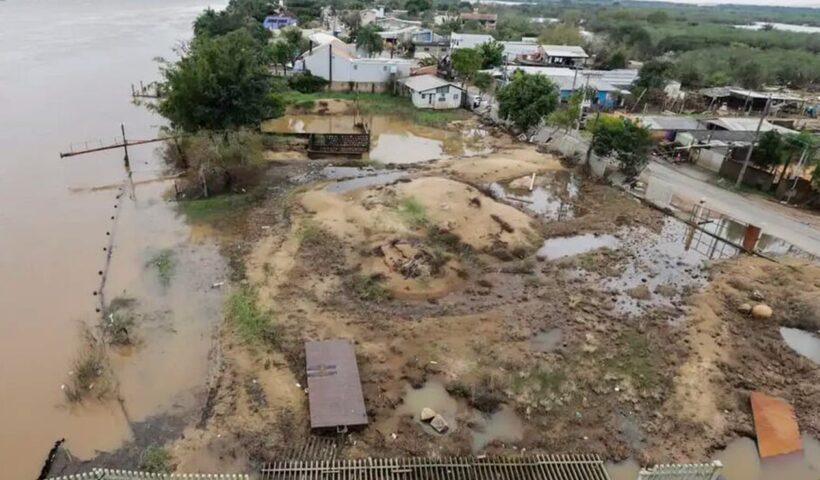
[157,30,284,132]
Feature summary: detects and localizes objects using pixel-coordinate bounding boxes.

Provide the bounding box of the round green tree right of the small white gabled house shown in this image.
[496,72,558,132]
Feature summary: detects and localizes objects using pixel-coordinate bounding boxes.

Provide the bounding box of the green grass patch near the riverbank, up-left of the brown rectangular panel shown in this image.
[225,286,276,345]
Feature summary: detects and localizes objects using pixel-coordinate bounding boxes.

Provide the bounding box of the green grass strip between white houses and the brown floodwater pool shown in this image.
[283,91,470,127]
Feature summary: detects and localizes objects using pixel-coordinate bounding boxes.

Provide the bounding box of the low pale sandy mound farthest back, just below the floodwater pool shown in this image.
[440,147,564,183]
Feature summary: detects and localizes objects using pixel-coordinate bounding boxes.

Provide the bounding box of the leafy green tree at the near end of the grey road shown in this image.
[587,115,652,176]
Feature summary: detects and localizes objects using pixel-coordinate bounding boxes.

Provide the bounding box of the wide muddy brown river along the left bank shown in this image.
[0,0,226,479]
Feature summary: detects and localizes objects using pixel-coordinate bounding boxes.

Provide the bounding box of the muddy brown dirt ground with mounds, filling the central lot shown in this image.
[62,110,820,472]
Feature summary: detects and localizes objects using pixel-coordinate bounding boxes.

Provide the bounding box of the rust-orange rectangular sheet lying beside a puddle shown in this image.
[752,392,803,458]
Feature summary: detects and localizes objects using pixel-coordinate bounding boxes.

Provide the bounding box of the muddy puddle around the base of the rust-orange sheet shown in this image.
[715,435,820,480]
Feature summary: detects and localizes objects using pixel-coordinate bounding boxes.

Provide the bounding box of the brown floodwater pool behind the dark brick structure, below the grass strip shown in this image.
[262,114,490,164]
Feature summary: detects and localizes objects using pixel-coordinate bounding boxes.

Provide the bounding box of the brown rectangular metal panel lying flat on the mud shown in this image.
[305,339,367,428]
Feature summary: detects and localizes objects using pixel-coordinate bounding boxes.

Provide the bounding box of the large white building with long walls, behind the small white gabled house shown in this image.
[302,40,415,92]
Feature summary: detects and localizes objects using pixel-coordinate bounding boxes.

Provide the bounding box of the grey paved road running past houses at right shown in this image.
[642,162,820,256]
